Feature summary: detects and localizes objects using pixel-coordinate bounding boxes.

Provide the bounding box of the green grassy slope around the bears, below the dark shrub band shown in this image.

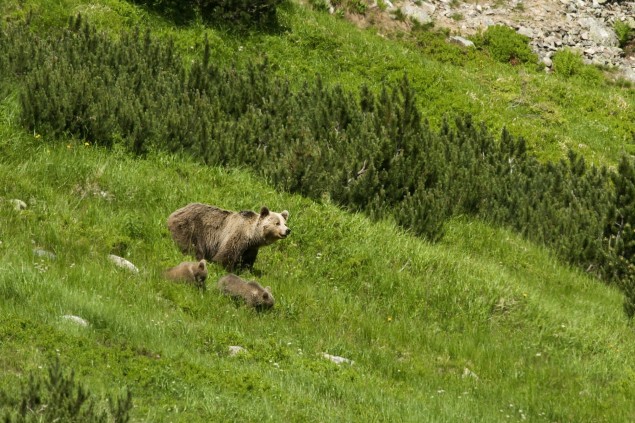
[0,91,635,422]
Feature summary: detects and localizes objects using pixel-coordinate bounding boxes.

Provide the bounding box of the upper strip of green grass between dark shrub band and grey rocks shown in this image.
[0,0,635,165]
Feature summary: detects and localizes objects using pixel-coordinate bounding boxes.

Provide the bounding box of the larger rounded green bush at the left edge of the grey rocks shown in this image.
[474,25,538,64]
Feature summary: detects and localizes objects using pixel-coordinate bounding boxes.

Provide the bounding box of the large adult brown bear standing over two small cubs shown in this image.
[168,203,291,272]
